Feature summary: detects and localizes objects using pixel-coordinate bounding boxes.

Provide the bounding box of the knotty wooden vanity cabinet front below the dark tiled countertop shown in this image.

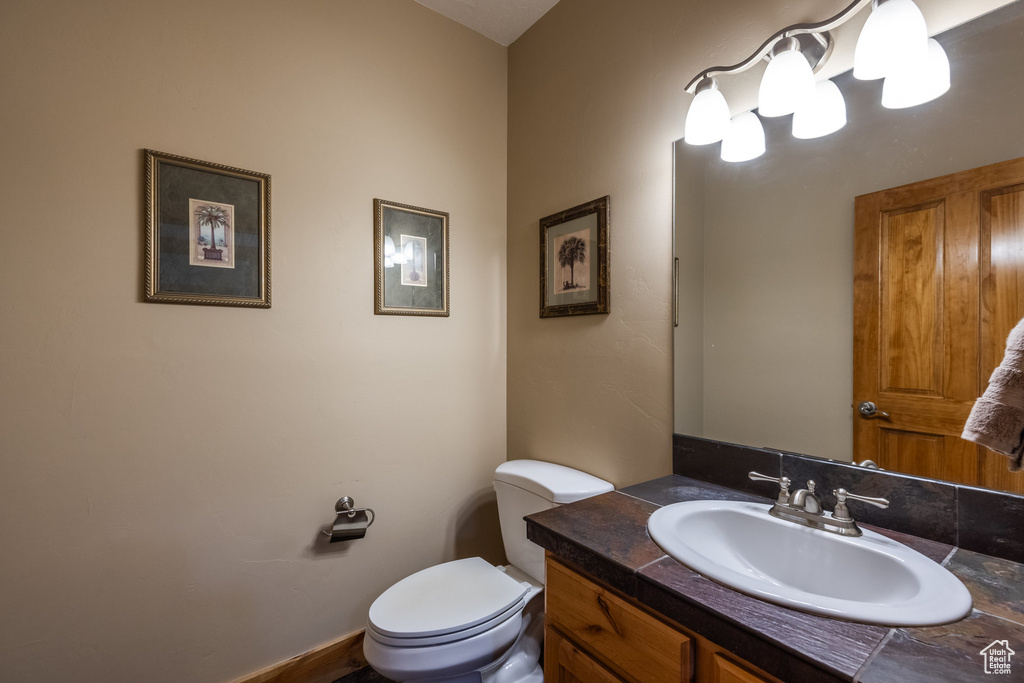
[544,553,781,683]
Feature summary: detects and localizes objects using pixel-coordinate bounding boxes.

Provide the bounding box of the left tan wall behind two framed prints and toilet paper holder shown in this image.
[0,0,507,683]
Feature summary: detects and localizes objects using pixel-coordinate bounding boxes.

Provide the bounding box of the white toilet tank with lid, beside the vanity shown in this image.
[495,460,614,583]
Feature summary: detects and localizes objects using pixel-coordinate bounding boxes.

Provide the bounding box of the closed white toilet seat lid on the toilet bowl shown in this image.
[368,557,531,647]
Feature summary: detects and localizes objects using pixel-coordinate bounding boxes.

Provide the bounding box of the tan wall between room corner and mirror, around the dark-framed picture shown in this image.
[508,0,1005,485]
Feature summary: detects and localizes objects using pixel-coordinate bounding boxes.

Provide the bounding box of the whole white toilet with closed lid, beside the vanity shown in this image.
[362,460,613,683]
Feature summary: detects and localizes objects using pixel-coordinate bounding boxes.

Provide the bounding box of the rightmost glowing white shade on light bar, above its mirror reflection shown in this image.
[853,0,928,81]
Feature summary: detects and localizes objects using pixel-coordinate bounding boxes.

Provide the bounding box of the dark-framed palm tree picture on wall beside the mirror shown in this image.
[541,196,610,317]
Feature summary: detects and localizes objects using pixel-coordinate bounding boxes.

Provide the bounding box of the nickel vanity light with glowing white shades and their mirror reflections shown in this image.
[683,0,949,161]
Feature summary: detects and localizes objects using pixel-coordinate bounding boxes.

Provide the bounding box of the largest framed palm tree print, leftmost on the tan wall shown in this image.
[144,150,270,308]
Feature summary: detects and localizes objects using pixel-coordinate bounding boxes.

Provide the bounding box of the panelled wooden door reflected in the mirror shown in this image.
[853,159,1024,493]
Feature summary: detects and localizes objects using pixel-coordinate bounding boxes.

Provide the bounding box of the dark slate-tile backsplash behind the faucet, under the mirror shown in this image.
[672,434,1024,562]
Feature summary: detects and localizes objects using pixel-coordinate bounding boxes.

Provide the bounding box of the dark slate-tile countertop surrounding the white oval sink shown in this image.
[526,475,1024,683]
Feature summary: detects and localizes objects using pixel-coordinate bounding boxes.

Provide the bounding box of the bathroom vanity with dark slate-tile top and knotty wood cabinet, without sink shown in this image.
[527,438,1024,683]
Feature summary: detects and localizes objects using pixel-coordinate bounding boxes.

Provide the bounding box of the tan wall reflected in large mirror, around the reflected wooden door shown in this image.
[674,2,1024,493]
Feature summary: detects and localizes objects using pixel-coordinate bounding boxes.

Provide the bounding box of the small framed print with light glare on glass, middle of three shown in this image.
[374,200,449,317]
